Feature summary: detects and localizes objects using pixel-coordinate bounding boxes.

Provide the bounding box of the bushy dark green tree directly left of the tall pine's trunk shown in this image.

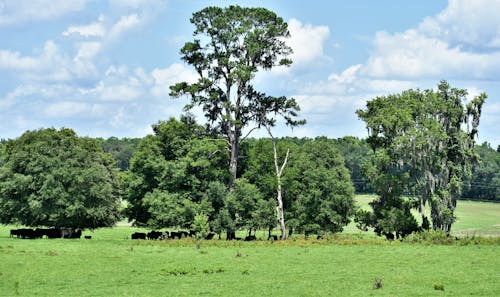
[124,115,229,228]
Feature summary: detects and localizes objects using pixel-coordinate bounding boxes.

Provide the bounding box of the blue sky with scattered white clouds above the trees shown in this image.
[0,0,500,148]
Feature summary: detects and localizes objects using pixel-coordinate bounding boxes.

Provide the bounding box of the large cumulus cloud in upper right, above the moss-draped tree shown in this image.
[364,0,500,80]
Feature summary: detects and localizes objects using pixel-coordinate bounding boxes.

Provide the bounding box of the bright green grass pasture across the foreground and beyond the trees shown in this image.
[0,197,500,296]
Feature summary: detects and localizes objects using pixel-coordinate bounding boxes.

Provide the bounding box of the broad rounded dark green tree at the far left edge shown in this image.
[0,129,120,229]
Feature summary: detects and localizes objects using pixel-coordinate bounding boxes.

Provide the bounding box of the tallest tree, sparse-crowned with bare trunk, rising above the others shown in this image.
[170,6,305,184]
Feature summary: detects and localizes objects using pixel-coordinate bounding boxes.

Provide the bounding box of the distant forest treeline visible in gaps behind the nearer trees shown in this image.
[95,136,500,202]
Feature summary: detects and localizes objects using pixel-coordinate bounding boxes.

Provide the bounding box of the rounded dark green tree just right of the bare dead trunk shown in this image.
[290,138,354,235]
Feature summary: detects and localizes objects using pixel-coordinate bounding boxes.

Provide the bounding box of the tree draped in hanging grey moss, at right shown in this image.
[357,81,486,231]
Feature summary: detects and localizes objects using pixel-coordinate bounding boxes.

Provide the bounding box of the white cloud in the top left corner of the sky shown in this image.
[0,0,87,26]
